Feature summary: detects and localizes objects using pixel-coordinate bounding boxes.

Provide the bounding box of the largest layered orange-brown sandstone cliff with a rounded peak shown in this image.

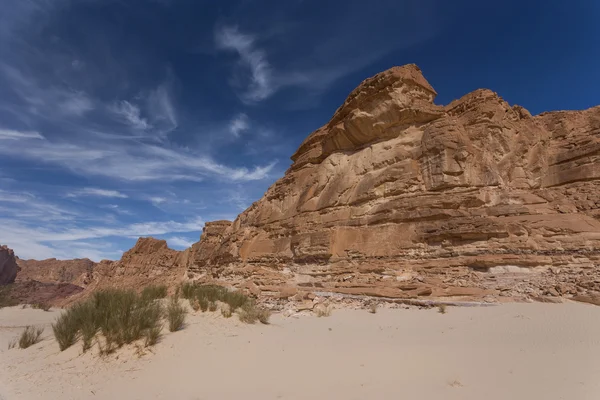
[189,65,600,297]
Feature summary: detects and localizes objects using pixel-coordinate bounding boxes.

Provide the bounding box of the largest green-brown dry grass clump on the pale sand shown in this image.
[52,289,163,353]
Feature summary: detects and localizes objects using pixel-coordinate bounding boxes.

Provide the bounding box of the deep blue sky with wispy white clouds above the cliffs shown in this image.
[0,0,600,260]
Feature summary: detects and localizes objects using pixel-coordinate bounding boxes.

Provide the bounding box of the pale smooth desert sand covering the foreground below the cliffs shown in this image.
[0,303,600,400]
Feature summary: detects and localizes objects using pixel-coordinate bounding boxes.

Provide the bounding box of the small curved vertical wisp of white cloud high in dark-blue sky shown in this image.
[215,26,276,102]
